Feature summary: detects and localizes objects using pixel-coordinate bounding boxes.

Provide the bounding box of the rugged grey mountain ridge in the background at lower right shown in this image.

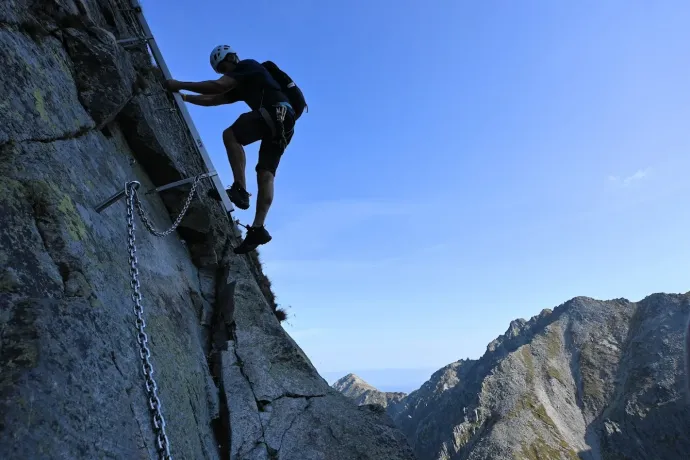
[334,294,690,460]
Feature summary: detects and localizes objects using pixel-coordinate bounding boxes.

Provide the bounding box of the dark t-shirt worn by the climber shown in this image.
[226,59,290,110]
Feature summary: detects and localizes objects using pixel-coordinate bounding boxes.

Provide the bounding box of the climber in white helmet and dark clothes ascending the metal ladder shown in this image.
[165,45,306,254]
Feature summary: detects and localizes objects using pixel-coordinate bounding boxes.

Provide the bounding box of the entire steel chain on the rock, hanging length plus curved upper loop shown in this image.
[125,176,201,460]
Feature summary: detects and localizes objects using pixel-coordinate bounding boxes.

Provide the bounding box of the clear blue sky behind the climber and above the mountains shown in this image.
[144,0,690,389]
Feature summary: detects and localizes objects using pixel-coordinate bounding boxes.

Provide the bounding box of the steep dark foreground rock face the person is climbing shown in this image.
[0,0,415,460]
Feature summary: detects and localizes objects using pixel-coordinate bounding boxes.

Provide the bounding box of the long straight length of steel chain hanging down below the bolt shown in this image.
[125,181,172,460]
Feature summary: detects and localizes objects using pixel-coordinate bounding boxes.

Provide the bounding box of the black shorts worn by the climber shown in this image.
[230,107,295,175]
